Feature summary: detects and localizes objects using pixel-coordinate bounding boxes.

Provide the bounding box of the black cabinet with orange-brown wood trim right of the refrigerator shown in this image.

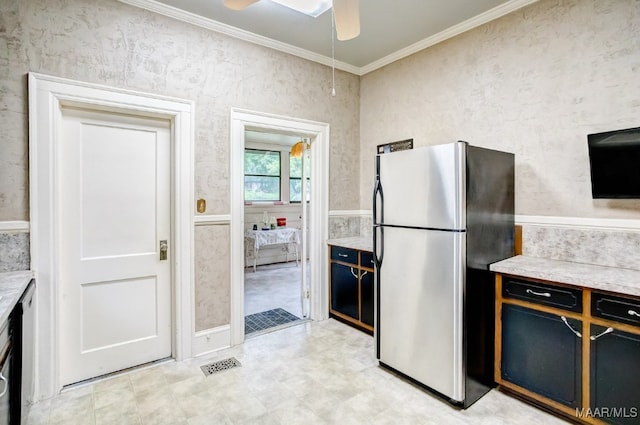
[492,255,640,425]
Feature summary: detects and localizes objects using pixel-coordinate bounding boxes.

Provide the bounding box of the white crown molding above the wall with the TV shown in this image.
[358,0,538,75]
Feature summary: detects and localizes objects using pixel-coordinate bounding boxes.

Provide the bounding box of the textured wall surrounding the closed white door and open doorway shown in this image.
[0,0,360,330]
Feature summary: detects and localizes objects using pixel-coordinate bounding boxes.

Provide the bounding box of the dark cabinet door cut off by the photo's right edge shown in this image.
[590,325,640,424]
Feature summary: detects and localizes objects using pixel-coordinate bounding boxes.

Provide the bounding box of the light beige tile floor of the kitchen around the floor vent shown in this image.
[28,319,565,425]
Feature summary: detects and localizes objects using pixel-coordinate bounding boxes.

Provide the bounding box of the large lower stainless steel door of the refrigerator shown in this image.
[376,227,465,402]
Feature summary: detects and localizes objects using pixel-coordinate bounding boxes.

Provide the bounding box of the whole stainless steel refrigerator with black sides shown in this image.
[373,142,514,408]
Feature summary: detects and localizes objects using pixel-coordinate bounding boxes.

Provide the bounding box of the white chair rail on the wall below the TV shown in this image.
[515,215,640,231]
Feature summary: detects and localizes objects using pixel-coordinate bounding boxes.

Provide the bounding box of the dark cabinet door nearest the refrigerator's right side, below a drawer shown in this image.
[501,304,582,407]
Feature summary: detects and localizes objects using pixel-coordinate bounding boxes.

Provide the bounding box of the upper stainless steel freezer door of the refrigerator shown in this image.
[376,142,466,229]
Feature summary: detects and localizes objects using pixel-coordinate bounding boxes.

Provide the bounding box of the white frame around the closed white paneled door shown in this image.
[29,73,194,400]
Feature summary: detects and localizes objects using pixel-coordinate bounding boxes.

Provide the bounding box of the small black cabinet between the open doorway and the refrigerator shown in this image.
[329,238,374,334]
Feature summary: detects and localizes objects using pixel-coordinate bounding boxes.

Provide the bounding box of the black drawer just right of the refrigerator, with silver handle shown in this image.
[502,278,582,313]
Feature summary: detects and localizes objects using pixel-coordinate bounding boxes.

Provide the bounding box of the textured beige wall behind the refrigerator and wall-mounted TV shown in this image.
[360,0,640,219]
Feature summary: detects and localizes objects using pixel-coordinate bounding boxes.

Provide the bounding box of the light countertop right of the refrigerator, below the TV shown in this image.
[490,255,640,296]
